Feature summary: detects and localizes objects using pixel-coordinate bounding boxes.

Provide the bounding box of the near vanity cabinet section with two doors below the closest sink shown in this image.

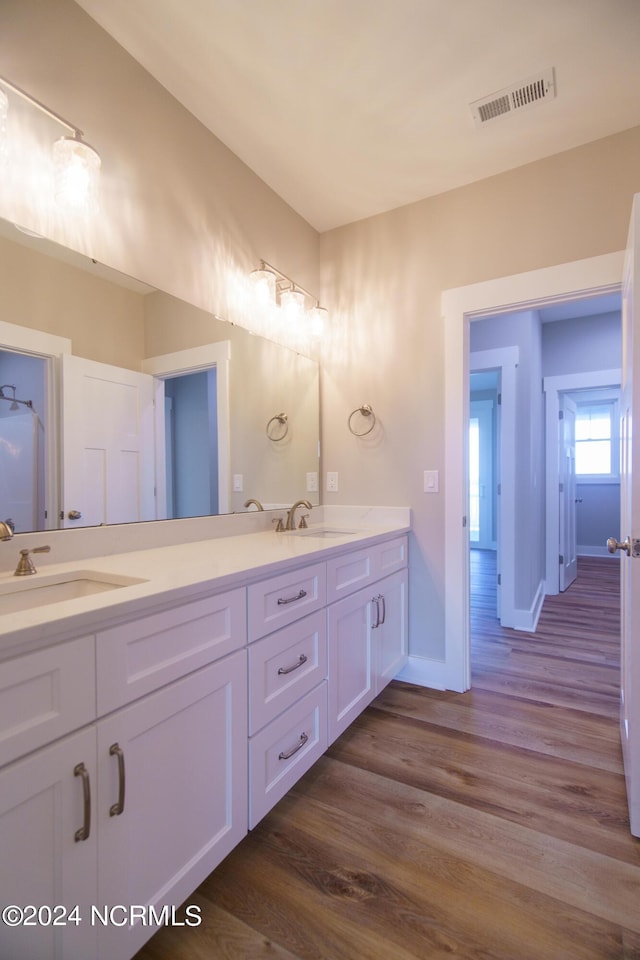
[0,588,248,960]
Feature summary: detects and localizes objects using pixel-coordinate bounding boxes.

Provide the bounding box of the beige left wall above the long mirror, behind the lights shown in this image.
[0,0,318,323]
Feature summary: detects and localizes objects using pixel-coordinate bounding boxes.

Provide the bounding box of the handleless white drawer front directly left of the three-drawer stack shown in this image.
[96,588,247,715]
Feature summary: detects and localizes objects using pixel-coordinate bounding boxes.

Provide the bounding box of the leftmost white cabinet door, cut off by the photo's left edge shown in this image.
[0,727,97,960]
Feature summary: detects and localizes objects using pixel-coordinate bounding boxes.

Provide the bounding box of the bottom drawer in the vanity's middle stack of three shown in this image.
[249,680,327,829]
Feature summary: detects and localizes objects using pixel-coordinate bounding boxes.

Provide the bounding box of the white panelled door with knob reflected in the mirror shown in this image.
[61,355,156,527]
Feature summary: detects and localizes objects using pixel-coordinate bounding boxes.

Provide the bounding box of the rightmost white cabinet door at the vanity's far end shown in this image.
[374,570,408,694]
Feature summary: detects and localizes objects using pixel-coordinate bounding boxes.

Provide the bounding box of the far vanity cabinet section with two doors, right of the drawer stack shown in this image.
[327,537,408,743]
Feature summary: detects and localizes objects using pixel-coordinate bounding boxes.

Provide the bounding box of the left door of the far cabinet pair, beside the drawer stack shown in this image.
[328,590,377,743]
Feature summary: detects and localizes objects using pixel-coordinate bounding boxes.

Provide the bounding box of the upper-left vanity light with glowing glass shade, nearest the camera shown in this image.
[0,77,101,213]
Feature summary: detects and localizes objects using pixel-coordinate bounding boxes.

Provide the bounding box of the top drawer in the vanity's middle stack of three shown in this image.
[248,563,327,642]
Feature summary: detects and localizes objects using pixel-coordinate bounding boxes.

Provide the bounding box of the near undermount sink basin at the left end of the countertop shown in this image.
[0,570,146,614]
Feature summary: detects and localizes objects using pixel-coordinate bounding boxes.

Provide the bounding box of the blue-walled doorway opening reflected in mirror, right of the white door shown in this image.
[164,367,219,518]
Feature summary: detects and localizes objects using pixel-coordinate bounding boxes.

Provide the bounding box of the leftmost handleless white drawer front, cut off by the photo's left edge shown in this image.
[0,637,96,765]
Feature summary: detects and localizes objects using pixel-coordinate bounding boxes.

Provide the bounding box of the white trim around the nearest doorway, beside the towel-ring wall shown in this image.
[441,251,624,691]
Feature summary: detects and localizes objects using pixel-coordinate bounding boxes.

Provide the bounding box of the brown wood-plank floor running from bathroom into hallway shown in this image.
[138,553,640,960]
